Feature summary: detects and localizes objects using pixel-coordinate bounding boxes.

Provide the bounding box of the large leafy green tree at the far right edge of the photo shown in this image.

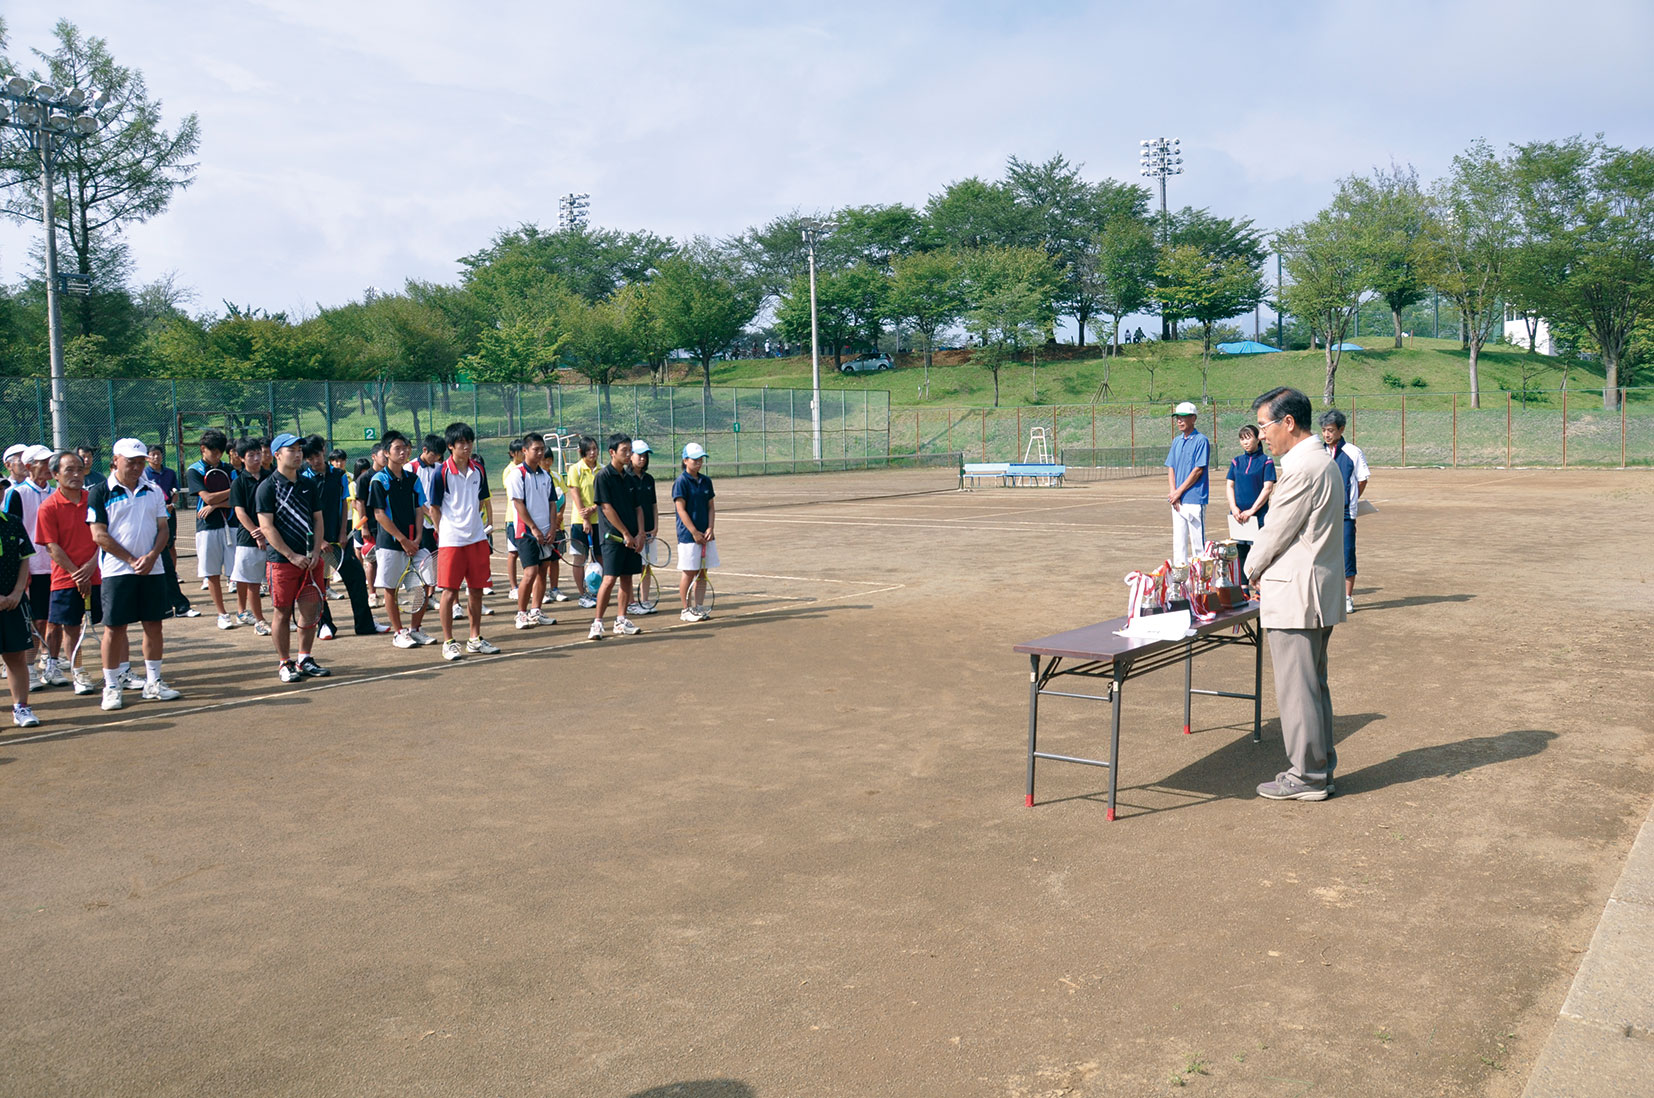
[1510,136,1654,408]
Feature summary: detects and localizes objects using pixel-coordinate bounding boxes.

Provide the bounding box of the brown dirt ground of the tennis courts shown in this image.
[0,470,1654,1098]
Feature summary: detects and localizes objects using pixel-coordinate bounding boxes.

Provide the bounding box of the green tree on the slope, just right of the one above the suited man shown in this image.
[1333,165,1431,349]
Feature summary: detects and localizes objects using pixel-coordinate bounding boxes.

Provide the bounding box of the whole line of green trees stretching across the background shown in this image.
[0,21,1654,413]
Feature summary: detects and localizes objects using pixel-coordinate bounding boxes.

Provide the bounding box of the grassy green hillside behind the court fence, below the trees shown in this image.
[683,339,1627,407]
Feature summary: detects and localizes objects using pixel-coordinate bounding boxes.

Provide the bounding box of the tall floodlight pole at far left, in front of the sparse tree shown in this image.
[0,76,109,450]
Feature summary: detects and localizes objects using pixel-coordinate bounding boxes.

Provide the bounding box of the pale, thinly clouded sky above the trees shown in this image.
[0,0,1654,322]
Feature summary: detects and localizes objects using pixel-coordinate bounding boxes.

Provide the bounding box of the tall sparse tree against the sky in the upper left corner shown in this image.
[0,20,200,336]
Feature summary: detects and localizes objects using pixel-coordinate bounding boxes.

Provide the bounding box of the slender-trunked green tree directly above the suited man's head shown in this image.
[1275,210,1374,405]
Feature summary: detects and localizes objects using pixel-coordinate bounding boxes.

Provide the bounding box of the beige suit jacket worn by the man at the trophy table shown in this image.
[1245,435,1345,628]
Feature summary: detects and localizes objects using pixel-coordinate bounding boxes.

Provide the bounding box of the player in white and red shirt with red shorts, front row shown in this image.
[428,423,500,660]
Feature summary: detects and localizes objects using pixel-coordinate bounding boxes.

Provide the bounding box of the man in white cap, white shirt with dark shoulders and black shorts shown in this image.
[86,438,180,709]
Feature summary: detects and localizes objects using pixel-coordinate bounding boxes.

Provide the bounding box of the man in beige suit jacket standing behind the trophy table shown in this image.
[1245,389,1345,800]
